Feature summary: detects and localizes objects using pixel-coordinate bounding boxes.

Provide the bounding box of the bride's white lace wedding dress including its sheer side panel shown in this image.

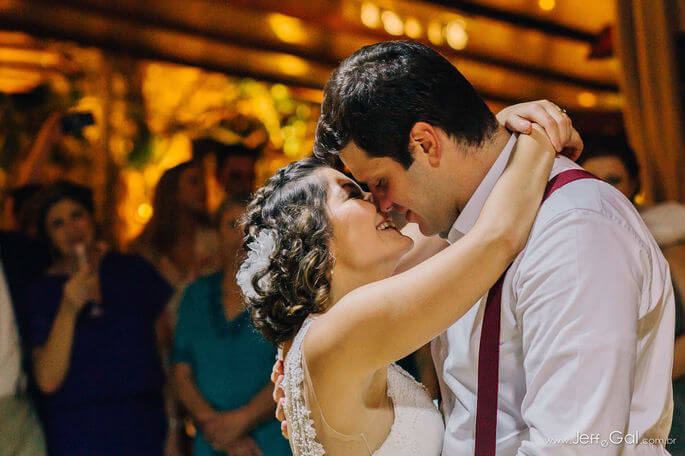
[282,317,444,456]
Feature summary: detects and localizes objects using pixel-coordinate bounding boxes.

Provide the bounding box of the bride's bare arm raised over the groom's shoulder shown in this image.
[304,125,555,378]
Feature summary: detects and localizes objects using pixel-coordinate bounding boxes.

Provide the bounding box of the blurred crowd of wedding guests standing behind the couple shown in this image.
[0,112,685,456]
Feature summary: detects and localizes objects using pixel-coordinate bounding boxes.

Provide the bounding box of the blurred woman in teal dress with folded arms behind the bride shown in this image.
[171,200,291,456]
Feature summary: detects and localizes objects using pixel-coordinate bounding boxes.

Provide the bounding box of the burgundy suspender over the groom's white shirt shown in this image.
[475,169,597,456]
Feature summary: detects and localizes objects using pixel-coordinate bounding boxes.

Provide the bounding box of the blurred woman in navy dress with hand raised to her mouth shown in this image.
[28,182,173,456]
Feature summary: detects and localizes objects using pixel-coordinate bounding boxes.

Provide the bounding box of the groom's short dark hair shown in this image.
[314,41,497,168]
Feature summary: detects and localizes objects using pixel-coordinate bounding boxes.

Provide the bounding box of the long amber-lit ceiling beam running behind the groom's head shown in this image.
[0,0,619,110]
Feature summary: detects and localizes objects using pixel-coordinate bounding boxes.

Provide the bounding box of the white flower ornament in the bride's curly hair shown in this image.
[235,230,276,299]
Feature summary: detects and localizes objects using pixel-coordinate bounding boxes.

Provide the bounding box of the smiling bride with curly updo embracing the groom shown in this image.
[237,119,572,456]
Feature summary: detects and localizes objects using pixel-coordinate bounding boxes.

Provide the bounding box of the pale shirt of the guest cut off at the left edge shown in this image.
[0,262,22,398]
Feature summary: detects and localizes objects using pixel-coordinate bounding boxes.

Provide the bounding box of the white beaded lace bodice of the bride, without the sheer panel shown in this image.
[282,317,444,456]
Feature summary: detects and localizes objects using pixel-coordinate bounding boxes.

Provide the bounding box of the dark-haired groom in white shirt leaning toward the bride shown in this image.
[274,42,674,456]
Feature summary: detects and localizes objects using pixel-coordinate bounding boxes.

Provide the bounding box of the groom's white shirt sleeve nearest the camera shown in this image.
[513,211,644,456]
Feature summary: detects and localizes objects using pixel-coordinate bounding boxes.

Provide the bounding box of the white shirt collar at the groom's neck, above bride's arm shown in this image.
[447,135,518,244]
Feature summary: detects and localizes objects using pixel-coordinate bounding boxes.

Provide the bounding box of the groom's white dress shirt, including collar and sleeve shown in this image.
[432,136,675,456]
